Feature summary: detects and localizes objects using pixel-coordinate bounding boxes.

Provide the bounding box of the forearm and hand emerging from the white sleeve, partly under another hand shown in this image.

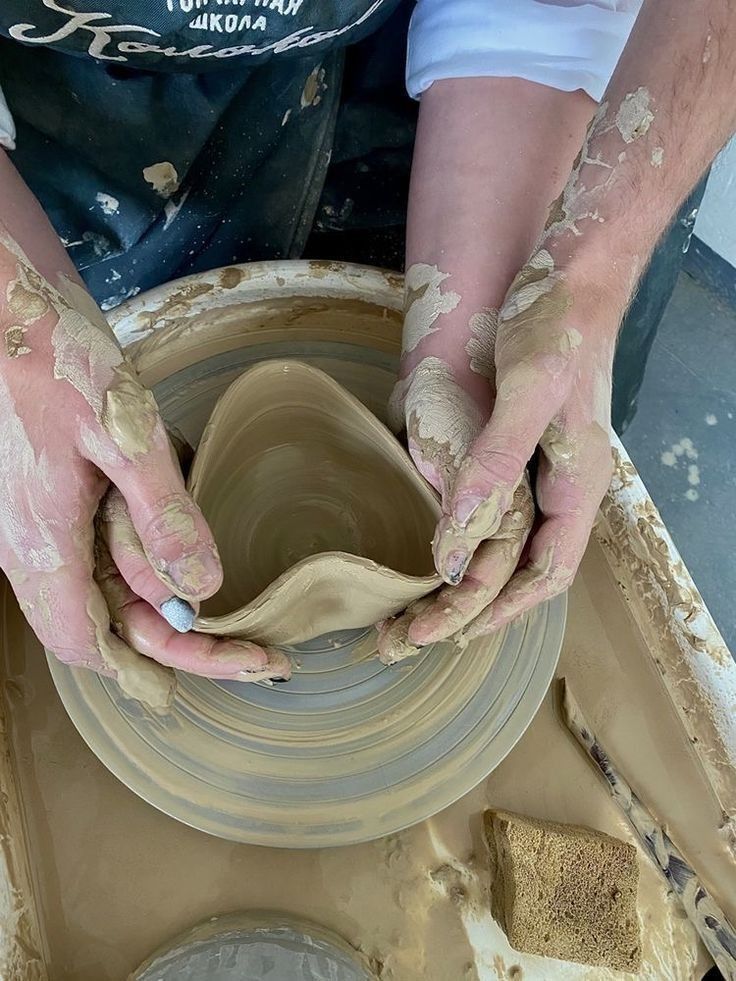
[379,78,594,661]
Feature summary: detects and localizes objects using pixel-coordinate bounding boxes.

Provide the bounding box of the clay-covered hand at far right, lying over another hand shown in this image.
[422,249,622,644]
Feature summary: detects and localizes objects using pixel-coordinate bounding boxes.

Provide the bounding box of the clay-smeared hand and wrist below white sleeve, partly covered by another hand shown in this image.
[379,263,534,663]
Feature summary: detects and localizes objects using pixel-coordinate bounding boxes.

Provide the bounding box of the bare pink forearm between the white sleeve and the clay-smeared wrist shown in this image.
[406,78,595,340]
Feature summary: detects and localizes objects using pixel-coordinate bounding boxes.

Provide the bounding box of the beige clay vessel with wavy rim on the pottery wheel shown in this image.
[189,361,441,645]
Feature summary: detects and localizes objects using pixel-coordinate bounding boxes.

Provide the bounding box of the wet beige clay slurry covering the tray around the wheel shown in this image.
[3,545,724,981]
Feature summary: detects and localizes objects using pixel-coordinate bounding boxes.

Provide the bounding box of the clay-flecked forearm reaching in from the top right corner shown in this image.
[544,0,736,298]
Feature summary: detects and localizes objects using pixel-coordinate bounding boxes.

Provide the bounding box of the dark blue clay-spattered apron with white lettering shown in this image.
[0,0,405,309]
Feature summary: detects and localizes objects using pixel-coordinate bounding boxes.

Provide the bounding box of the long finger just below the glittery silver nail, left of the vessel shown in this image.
[95,547,291,681]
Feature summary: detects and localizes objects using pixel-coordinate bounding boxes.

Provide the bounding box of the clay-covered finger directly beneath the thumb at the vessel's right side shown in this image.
[408,481,534,645]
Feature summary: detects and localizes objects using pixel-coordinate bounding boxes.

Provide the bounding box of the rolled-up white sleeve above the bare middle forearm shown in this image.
[406,0,642,102]
